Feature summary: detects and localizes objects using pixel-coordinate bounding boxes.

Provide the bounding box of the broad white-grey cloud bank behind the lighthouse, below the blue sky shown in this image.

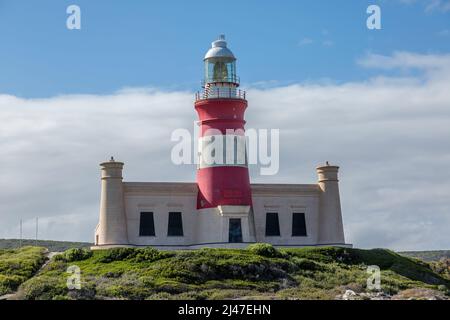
[0,52,450,250]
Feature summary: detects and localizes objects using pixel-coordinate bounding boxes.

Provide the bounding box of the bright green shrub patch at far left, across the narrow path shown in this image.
[0,247,46,296]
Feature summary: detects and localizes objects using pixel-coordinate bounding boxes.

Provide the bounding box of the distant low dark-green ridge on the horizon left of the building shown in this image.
[0,239,92,252]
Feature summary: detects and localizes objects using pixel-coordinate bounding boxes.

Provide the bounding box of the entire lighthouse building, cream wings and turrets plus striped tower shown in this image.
[94,36,349,249]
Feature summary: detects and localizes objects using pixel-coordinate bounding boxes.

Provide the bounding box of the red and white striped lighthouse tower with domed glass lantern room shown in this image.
[195,35,252,244]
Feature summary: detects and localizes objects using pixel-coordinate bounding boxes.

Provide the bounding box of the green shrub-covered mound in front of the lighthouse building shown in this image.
[12,244,450,300]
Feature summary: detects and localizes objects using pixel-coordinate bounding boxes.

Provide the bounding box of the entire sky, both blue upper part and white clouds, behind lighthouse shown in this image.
[0,0,450,250]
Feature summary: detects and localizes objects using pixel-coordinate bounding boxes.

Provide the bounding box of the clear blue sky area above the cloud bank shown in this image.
[0,0,450,97]
